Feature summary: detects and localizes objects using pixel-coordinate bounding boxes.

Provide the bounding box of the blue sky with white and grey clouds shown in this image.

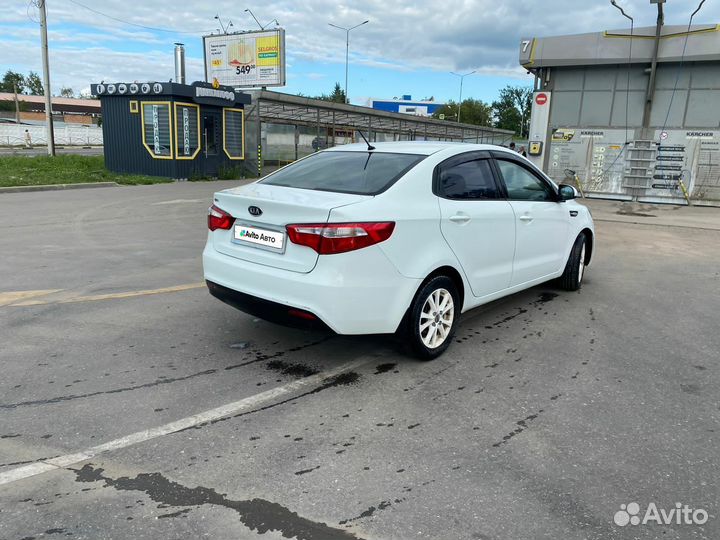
[0,0,720,104]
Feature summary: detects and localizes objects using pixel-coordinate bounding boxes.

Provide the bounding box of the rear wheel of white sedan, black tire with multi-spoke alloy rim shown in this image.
[401,276,462,360]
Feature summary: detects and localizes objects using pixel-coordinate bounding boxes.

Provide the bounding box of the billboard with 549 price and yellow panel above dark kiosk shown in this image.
[203,28,285,88]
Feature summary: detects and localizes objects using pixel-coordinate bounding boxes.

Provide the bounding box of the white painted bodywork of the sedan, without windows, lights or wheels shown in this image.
[203,142,594,334]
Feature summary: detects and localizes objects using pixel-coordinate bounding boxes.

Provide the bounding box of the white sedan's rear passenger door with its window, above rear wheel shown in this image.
[434,152,515,297]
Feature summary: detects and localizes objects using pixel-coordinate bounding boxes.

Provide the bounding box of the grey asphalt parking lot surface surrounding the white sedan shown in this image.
[0,182,720,540]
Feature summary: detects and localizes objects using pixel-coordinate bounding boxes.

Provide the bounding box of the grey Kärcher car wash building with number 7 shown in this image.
[520,16,720,204]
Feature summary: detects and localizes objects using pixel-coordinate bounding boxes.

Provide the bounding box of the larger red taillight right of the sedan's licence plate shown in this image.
[287,221,395,255]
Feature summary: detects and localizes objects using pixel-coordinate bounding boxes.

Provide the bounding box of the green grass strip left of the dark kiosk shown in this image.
[0,154,172,187]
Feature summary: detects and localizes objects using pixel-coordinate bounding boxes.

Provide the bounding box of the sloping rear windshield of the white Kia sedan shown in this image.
[260,151,426,195]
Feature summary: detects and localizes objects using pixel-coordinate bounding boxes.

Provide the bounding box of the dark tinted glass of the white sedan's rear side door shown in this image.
[438,159,501,200]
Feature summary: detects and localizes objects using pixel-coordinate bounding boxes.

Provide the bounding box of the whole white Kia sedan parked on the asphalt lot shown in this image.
[203,142,595,359]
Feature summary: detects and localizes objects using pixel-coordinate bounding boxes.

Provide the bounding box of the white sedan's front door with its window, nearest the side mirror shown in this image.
[495,152,570,287]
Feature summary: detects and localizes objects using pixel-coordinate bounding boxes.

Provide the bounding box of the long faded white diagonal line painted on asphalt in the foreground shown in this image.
[0,357,373,486]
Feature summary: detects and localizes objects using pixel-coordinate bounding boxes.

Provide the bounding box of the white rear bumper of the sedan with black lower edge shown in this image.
[203,242,421,334]
